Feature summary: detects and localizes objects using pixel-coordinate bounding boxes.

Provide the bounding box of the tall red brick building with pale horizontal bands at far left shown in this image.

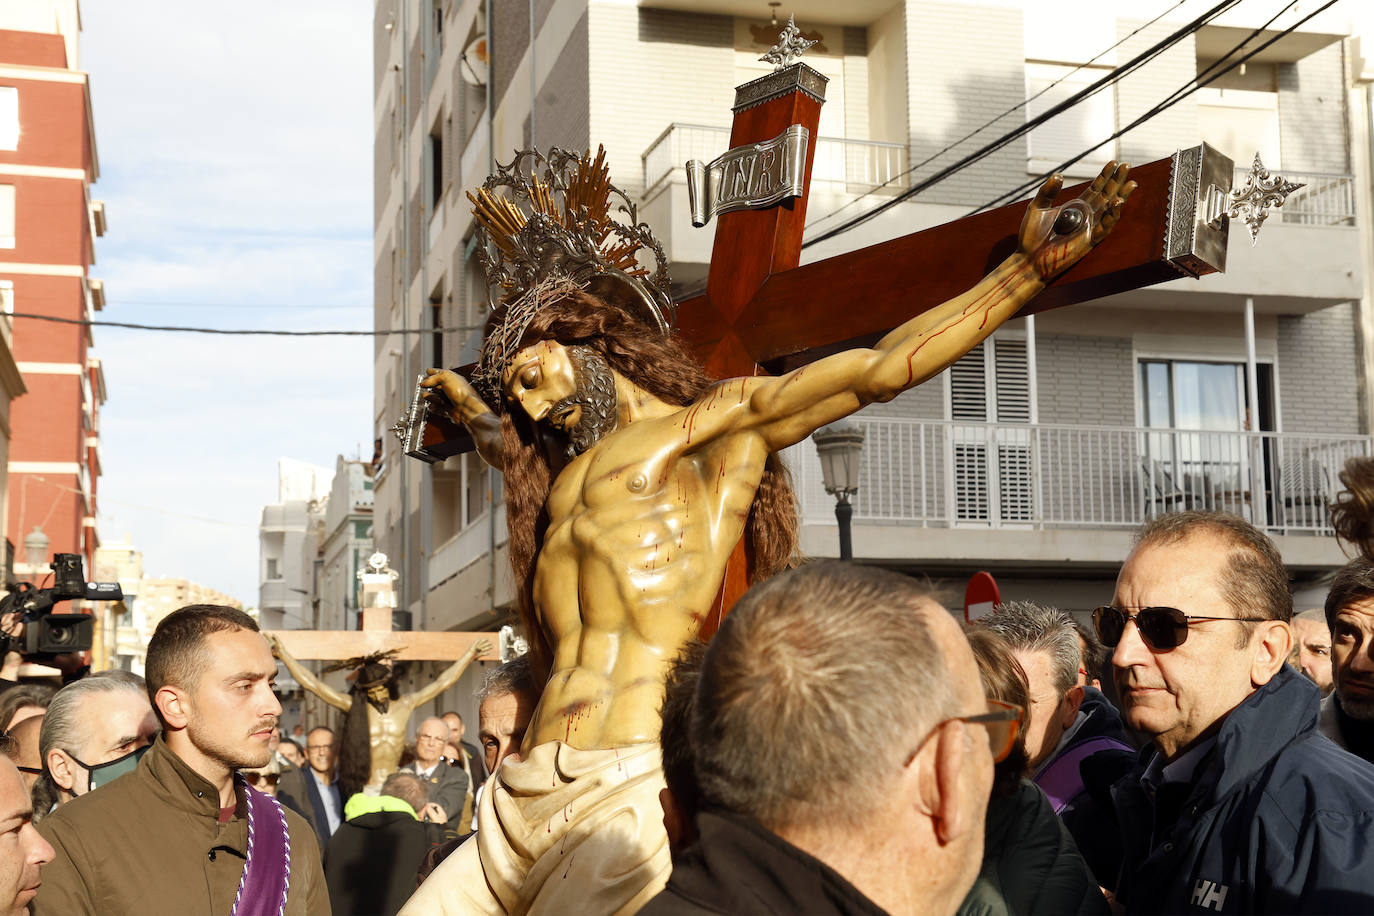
[0,7,104,574]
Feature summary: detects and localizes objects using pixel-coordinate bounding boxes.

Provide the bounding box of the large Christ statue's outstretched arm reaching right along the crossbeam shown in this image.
[741,162,1135,450]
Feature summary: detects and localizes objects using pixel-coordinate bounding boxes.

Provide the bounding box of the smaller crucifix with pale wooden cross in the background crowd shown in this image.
[265,553,493,798]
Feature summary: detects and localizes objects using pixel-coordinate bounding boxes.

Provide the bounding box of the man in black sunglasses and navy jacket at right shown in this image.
[1094,512,1374,913]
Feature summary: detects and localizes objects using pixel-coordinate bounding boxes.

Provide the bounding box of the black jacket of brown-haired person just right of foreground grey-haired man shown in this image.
[959,780,1110,916]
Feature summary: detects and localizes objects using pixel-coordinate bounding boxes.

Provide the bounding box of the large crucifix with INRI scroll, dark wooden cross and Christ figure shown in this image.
[400,16,1308,915]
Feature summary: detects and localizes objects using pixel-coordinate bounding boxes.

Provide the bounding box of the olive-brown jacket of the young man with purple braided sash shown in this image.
[33,736,330,916]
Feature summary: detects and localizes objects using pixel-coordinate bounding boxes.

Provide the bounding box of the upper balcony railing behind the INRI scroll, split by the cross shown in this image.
[642,122,907,196]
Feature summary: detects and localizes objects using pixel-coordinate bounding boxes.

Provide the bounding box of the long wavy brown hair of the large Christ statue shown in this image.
[488,291,797,684]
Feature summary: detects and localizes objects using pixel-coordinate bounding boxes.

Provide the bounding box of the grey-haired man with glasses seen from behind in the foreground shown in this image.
[640,562,1018,916]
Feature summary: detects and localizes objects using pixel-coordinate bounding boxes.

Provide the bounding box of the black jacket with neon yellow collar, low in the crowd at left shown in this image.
[324,794,441,916]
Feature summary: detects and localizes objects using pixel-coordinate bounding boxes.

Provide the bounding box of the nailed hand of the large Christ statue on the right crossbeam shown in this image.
[1018,162,1136,283]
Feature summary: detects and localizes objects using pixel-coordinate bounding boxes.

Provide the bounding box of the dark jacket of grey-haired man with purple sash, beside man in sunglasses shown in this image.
[1033,687,1136,887]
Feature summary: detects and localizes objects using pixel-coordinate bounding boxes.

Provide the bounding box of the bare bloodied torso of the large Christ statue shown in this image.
[526,409,767,748]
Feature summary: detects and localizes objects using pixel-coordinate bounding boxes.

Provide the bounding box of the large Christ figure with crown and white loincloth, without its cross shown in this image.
[407,112,1135,913]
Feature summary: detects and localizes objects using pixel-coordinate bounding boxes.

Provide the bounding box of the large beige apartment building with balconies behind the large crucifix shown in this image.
[374,0,1374,629]
